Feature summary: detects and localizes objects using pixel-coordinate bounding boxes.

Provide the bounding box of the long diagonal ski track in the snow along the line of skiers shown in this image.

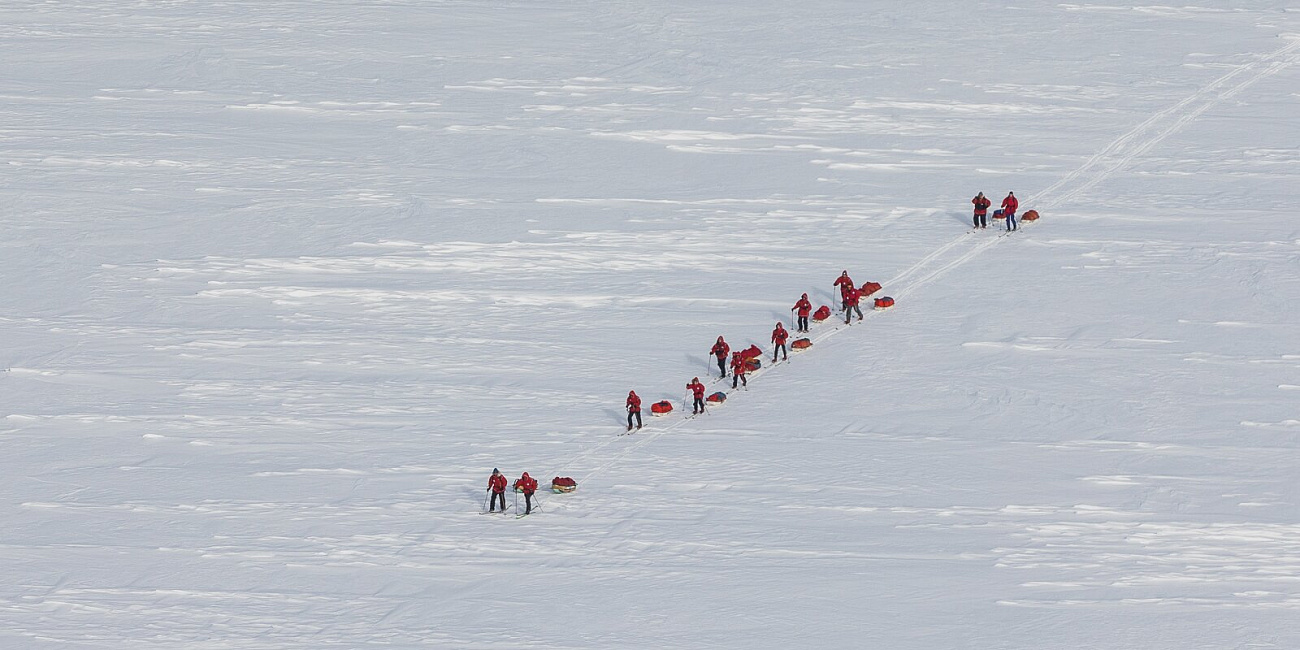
[533,40,1300,508]
